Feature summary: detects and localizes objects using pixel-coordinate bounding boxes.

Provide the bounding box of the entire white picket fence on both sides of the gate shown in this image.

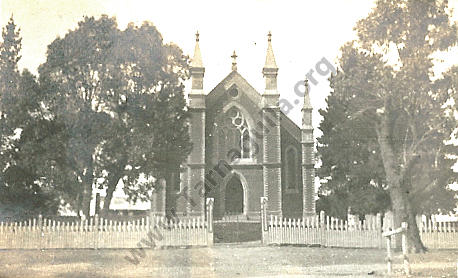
[0,199,458,249]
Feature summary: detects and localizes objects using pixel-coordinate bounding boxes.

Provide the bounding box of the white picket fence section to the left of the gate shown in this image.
[0,198,213,249]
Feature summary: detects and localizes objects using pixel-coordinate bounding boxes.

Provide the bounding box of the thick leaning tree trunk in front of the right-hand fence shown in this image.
[377,118,425,253]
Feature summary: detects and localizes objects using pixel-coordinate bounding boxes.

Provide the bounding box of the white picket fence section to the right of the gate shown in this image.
[261,198,458,249]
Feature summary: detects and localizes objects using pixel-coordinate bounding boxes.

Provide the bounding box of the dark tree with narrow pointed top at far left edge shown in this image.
[0,18,59,218]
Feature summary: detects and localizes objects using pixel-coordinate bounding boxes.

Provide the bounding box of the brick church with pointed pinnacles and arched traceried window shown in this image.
[151,33,315,219]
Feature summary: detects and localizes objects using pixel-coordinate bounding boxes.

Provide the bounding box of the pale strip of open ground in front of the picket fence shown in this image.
[0,243,458,278]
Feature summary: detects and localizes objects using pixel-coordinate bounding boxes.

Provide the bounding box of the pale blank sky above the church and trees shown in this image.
[0,0,458,131]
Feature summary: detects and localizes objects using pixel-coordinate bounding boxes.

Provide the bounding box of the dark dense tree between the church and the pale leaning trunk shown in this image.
[317,81,390,219]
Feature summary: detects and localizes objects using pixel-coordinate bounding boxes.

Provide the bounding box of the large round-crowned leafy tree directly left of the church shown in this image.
[40,16,191,217]
